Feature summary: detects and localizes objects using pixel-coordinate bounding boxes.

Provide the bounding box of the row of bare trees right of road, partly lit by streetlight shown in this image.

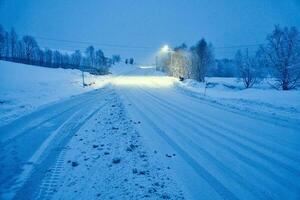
[158,25,300,90]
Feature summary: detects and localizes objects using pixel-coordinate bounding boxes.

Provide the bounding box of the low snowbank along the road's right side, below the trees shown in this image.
[177,77,300,123]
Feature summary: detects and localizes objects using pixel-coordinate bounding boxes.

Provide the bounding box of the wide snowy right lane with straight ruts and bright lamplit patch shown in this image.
[115,66,300,199]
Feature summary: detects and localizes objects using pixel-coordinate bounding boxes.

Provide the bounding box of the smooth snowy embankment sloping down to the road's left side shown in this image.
[0,61,108,125]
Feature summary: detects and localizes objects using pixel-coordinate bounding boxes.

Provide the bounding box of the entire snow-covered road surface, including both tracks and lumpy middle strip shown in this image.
[0,65,300,199]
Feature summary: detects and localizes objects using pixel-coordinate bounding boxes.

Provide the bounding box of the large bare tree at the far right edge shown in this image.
[261,25,300,90]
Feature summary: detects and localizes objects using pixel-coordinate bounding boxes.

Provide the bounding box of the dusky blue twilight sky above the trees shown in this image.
[0,0,300,62]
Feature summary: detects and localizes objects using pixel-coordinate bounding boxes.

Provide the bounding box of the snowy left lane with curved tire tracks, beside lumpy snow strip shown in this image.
[0,90,109,198]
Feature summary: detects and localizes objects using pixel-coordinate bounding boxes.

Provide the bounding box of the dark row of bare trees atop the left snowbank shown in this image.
[0,25,115,74]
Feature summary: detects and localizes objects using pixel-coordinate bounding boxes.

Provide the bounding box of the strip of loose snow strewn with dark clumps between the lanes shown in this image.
[47,89,183,199]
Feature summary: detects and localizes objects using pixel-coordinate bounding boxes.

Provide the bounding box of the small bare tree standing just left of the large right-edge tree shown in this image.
[235,50,261,88]
